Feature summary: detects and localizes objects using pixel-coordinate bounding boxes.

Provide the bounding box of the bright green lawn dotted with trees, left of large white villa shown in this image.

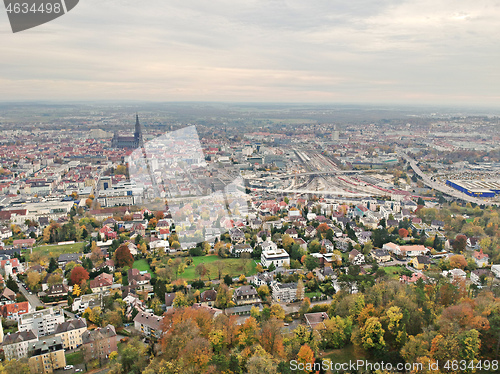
[179,256,257,282]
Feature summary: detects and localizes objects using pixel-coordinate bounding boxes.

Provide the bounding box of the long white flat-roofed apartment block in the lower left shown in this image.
[18,308,64,337]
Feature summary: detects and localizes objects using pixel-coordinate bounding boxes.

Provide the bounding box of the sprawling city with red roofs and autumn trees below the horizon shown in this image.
[0,103,500,374]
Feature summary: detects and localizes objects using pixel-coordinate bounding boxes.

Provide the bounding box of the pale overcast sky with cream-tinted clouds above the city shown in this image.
[0,0,500,107]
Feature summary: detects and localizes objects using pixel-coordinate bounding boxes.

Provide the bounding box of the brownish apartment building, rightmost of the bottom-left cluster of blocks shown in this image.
[82,325,118,361]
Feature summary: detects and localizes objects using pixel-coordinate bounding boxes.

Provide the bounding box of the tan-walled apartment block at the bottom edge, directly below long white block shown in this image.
[28,336,66,373]
